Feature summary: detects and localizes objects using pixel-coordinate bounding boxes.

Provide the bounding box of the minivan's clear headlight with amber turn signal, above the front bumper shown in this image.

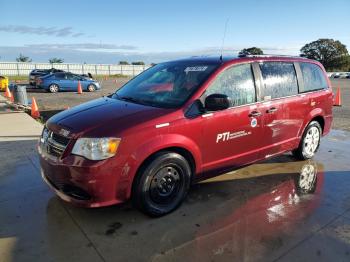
[72,137,120,160]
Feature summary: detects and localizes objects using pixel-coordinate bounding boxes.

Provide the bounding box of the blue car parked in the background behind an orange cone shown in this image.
[36,72,101,93]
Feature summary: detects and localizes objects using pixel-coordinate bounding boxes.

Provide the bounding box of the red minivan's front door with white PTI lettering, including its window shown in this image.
[202,64,263,171]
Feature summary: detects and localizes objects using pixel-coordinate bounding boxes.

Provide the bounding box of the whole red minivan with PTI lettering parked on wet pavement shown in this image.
[38,56,333,216]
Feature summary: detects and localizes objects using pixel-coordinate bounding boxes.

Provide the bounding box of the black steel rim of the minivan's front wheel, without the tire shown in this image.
[150,165,183,204]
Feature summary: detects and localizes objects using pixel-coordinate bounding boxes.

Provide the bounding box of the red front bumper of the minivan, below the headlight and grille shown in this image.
[39,150,130,207]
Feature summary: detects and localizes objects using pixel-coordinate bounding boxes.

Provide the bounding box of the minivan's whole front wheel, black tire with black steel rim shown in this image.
[132,152,191,217]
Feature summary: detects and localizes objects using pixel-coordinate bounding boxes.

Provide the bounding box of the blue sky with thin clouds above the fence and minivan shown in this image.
[0,0,350,64]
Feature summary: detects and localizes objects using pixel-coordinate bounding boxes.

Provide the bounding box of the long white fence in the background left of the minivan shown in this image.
[0,62,150,76]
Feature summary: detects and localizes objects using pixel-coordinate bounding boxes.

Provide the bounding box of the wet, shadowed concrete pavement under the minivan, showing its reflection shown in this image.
[0,131,350,262]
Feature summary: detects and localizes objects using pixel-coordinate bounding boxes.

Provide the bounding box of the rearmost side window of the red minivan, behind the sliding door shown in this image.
[299,63,328,92]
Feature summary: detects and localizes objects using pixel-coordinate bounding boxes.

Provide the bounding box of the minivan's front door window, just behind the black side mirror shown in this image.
[205,64,256,106]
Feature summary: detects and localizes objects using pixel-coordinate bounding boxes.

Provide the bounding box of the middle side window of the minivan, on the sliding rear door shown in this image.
[260,62,298,98]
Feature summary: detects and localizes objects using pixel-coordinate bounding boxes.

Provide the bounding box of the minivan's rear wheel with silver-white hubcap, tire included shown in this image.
[293,121,322,160]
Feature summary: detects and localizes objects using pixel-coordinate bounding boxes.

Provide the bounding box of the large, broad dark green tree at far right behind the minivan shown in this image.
[300,38,350,71]
